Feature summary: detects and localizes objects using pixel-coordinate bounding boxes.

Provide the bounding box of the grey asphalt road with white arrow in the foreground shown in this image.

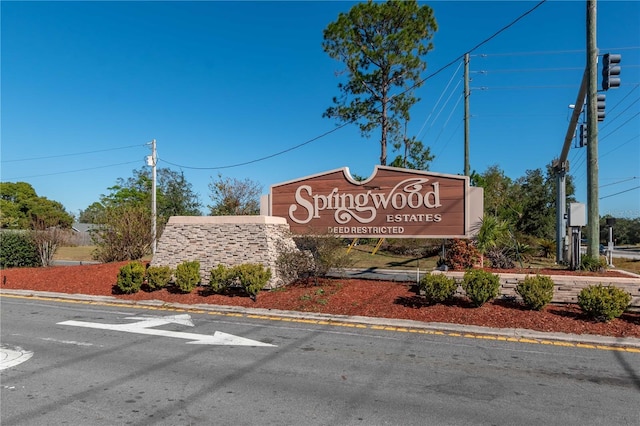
[0,297,640,426]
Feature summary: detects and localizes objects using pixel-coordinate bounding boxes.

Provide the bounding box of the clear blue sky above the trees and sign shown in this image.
[0,0,640,217]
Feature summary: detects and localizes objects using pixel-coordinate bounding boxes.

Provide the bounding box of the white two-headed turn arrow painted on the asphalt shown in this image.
[58,315,275,346]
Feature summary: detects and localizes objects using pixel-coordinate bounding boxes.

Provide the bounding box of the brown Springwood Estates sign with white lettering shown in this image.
[269,166,483,238]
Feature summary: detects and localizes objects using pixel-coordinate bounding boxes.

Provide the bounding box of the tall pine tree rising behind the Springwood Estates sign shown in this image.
[322,0,437,165]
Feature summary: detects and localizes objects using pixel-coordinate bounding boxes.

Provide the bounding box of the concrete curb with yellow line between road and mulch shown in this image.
[5,289,640,350]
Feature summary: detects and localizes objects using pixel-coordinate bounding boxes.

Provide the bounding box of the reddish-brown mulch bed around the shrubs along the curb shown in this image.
[1,262,640,338]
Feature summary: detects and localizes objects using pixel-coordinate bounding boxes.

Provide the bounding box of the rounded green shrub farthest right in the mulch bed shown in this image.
[578,284,631,322]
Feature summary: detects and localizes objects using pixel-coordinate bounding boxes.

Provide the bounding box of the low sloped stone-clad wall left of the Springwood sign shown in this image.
[151,216,295,288]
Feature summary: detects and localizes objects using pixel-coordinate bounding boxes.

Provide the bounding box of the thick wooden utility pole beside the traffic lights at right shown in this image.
[587,0,600,258]
